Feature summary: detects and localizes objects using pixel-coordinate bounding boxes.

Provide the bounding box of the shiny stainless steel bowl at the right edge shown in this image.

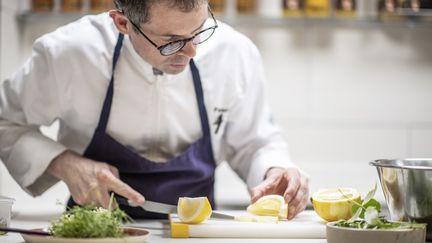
[370,159,432,240]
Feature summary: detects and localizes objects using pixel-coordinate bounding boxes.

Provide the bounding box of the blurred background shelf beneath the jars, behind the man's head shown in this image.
[18,12,432,28]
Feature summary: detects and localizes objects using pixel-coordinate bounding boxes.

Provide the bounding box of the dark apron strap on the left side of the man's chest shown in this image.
[96,33,124,132]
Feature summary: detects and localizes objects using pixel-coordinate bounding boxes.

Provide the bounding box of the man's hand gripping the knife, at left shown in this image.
[47,151,144,208]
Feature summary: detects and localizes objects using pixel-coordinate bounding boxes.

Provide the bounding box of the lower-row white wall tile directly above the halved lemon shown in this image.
[282,122,408,163]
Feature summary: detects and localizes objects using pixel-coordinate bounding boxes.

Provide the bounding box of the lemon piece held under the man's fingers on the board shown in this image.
[247,195,288,219]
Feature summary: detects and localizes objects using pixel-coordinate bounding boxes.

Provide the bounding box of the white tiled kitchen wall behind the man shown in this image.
[1,1,432,212]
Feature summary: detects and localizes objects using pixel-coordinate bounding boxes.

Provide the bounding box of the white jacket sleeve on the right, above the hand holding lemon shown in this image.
[224,40,296,188]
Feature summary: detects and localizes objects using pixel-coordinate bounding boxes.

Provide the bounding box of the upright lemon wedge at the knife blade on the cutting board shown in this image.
[177,197,212,224]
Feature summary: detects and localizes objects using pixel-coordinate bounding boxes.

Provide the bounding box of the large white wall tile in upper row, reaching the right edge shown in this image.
[311,26,432,122]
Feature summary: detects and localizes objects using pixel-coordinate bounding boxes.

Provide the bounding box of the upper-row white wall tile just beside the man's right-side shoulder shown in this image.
[243,28,309,119]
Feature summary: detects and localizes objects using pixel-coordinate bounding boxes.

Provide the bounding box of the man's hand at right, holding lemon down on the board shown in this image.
[251,167,309,219]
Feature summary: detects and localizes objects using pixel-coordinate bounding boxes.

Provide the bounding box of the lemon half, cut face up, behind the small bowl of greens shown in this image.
[311,188,360,222]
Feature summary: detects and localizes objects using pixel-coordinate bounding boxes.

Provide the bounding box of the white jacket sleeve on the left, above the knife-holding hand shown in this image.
[0,39,66,195]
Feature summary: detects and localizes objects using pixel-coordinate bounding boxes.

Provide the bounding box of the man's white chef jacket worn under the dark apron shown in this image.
[0,13,295,195]
